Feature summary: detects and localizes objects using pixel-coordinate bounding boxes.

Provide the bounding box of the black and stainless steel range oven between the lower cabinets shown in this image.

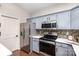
[39,35,57,56]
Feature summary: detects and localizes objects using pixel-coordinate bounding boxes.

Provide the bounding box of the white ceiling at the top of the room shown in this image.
[17,3,56,14]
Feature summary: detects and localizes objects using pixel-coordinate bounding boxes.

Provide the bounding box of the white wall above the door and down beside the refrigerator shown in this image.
[0,3,29,51]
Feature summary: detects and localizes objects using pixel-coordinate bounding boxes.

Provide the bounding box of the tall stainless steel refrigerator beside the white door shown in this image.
[20,20,30,53]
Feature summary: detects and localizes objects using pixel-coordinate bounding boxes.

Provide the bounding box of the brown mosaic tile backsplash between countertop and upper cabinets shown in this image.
[37,30,79,43]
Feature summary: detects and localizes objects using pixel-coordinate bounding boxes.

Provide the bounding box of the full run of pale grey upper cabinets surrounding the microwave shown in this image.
[30,7,79,29]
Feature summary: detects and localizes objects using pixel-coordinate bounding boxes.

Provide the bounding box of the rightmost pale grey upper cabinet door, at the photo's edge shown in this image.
[71,7,79,29]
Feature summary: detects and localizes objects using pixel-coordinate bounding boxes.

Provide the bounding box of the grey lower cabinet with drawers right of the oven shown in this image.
[55,42,75,56]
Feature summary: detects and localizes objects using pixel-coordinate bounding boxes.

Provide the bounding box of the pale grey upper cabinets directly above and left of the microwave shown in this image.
[35,14,56,29]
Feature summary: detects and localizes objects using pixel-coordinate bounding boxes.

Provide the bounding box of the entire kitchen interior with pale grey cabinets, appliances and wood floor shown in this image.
[0,3,79,56]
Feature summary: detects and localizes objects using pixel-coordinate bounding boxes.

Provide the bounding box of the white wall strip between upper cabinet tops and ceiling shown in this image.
[31,3,79,17]
